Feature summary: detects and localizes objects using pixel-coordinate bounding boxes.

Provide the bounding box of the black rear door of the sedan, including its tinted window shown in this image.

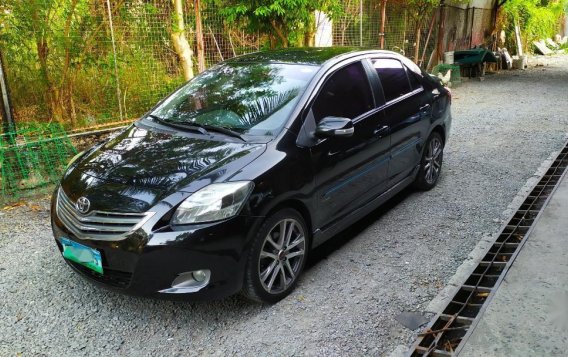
[371,58,430,187]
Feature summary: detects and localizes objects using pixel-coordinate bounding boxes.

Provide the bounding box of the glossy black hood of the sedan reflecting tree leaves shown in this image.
[62,126,266,209]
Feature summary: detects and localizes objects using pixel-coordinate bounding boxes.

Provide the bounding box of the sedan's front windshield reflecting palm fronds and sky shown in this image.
[146,63,318,136]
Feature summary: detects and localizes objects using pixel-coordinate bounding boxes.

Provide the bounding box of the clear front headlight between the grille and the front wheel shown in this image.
[171,181,254,225]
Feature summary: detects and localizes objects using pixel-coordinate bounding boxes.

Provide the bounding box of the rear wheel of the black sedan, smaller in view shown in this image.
[414,132,444,191]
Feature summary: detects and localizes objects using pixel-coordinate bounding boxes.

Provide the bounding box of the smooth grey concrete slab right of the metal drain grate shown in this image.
[460,172,568,357]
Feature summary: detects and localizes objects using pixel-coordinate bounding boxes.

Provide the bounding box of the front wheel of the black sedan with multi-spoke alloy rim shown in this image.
[242,208,309,304]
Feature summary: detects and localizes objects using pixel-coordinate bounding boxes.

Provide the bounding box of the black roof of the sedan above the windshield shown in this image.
[226,47,397,66]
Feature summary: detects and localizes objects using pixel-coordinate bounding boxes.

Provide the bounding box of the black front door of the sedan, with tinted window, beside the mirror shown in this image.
[308,61,390,227]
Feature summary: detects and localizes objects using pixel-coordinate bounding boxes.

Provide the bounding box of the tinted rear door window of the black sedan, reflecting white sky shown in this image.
[373,58,411,102]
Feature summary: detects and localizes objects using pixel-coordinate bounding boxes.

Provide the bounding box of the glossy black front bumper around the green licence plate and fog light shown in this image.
[52,199,256,300]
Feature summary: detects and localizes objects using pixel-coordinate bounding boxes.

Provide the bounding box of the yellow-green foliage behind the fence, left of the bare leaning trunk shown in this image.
[0,0,182,128]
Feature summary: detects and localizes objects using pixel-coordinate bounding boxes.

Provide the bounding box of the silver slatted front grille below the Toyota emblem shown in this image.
[56,189,154,241]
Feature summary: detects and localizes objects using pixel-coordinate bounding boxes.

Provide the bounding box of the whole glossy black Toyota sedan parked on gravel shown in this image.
[52,48,451,303]
